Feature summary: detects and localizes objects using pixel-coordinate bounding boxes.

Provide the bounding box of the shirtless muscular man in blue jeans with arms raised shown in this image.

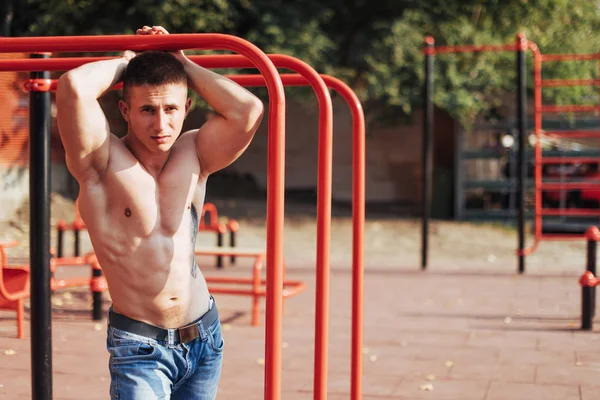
[56,26,263,400]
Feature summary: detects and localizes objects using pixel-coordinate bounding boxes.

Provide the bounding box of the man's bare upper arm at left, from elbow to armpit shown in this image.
[56,79,110,179]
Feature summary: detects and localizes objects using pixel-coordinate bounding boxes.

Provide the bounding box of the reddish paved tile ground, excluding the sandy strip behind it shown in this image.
[0,250,600,400]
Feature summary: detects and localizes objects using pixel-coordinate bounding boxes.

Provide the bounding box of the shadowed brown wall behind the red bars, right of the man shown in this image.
[229,98,455,204]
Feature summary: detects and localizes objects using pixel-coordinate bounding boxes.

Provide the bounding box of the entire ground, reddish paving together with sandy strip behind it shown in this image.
[0,198,600,400]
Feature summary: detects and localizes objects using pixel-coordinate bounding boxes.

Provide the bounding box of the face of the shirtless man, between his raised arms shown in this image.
[119,84,191,152]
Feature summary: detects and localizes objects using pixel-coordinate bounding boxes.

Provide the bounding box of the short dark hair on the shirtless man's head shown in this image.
[123,51,187,100]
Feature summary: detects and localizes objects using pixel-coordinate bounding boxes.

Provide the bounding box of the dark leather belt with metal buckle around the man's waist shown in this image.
[108,302,219,344]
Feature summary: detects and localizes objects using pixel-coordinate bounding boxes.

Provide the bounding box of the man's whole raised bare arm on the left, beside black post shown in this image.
[56,52,135,183]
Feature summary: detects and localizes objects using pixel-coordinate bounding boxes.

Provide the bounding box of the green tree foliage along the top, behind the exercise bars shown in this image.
[10,0,600,128]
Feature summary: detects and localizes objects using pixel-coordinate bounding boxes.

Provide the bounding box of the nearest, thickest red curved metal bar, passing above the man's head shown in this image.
[0,33,285,400]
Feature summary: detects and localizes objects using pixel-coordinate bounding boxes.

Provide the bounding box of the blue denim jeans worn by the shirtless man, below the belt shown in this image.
[106,308,224,400]
